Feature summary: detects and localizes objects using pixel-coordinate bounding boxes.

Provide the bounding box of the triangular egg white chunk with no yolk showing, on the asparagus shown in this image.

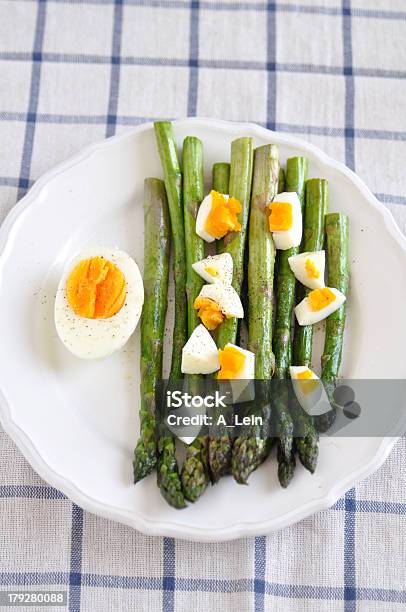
[181,325,220,374]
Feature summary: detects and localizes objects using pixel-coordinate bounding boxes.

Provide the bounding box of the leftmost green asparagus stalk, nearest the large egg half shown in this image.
[134,178,170,482]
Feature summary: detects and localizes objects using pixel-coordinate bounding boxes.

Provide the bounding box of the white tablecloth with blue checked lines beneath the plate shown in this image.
[0,0,406,612]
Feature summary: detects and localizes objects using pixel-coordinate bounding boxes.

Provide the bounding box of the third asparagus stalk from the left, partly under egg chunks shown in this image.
[181,136,209,502]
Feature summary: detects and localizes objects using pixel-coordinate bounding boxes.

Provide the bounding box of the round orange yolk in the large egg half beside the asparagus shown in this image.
[66,257,126,319]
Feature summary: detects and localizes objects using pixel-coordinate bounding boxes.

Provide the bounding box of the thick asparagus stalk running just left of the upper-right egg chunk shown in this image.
[231,145,279,484]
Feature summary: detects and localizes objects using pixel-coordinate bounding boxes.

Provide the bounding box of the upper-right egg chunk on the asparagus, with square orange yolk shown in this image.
[268,191,302,251]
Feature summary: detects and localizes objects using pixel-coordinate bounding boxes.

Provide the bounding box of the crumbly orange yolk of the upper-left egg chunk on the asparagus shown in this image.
[204,190,241,240]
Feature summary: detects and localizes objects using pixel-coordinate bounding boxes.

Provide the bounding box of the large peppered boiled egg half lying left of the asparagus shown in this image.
[55,247,144,359]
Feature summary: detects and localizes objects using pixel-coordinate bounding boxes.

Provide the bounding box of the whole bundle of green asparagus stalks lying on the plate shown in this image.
[134,121,349,508]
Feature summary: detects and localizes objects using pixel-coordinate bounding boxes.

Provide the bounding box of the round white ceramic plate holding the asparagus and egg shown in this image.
[0,119,406,541]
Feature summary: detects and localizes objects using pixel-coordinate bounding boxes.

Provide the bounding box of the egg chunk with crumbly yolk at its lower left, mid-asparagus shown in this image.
[193,283,244,330]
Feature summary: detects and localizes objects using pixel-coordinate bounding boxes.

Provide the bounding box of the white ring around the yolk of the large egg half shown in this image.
[54,246,144,359]
